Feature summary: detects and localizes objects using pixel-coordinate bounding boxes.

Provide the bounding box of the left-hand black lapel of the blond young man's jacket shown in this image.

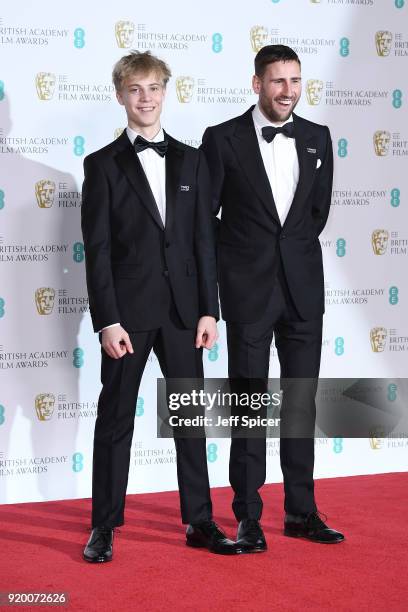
[116,130,164,229]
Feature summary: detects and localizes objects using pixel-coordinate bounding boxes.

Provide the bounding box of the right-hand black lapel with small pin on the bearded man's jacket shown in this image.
[284,114,317,226]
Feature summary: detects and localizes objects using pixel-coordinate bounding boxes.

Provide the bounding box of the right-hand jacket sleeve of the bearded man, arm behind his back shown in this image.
[311,127,333,236]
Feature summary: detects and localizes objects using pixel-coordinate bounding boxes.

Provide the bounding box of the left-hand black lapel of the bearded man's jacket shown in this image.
[231,108,280,224]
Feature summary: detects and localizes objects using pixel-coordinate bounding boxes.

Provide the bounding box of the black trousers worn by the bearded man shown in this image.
[227,268,322,521]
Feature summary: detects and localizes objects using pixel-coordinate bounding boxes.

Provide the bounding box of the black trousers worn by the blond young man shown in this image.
[92,292,212,527]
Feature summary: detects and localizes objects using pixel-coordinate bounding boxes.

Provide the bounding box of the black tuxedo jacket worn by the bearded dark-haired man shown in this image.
[202,107,333,323]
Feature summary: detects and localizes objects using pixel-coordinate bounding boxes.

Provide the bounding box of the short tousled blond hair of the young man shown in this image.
[112,51,171,91]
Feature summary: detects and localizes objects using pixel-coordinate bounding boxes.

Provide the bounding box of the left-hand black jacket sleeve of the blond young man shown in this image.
[81,155,120,331]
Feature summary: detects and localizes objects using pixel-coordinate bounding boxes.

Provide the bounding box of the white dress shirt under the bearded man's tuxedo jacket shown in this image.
[252,104,299,225]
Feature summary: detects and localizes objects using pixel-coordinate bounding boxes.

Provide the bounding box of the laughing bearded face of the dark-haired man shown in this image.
[252,61,302,123]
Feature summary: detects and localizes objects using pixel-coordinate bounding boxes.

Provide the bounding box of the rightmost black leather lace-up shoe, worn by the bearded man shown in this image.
[283,512,345,544]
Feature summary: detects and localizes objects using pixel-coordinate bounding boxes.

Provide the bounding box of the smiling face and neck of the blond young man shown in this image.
[116,72,166,138]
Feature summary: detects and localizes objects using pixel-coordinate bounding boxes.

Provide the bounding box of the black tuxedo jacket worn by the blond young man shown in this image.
[81,131,218,332]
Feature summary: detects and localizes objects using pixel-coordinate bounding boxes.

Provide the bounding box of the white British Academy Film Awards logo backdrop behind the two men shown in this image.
[0,0,408,503]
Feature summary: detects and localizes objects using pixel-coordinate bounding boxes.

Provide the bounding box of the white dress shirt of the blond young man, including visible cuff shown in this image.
[98,126,166,333]
